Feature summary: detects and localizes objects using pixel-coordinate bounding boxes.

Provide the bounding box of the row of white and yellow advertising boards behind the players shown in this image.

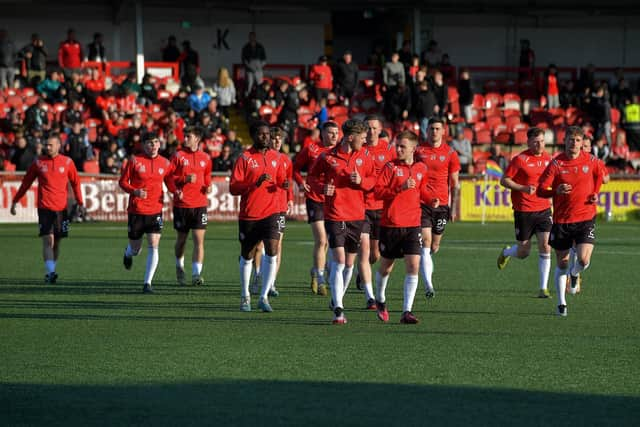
[0,172,640,223]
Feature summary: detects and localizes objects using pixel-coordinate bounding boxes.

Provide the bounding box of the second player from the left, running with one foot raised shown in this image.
[120,135,176,293]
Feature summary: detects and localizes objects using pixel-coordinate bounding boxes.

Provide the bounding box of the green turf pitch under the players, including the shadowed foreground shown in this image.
[0,219,640,426]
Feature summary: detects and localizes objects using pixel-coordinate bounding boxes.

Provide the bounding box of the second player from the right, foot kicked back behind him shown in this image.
[498,127,553,298]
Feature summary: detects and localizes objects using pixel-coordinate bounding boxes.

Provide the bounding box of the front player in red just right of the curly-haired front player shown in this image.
[375,131,427,323]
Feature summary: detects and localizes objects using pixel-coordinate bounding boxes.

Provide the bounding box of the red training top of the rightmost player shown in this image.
[537,152,604,224]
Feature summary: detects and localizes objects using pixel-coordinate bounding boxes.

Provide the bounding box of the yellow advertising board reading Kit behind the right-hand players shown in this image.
[460,179,640,221]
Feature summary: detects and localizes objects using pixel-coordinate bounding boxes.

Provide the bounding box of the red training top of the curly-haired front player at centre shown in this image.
[311,144,376,221]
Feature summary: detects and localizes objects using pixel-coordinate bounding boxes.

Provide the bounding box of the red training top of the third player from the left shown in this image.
[171,150,211,208]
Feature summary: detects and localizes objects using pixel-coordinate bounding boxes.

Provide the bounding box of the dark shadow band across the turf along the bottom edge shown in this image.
[0,382,640,427]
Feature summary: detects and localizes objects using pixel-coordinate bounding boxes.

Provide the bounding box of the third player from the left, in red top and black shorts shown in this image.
[171,127,212,286]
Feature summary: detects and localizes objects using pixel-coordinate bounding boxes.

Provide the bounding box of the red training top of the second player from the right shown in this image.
[504,150,551,212]
